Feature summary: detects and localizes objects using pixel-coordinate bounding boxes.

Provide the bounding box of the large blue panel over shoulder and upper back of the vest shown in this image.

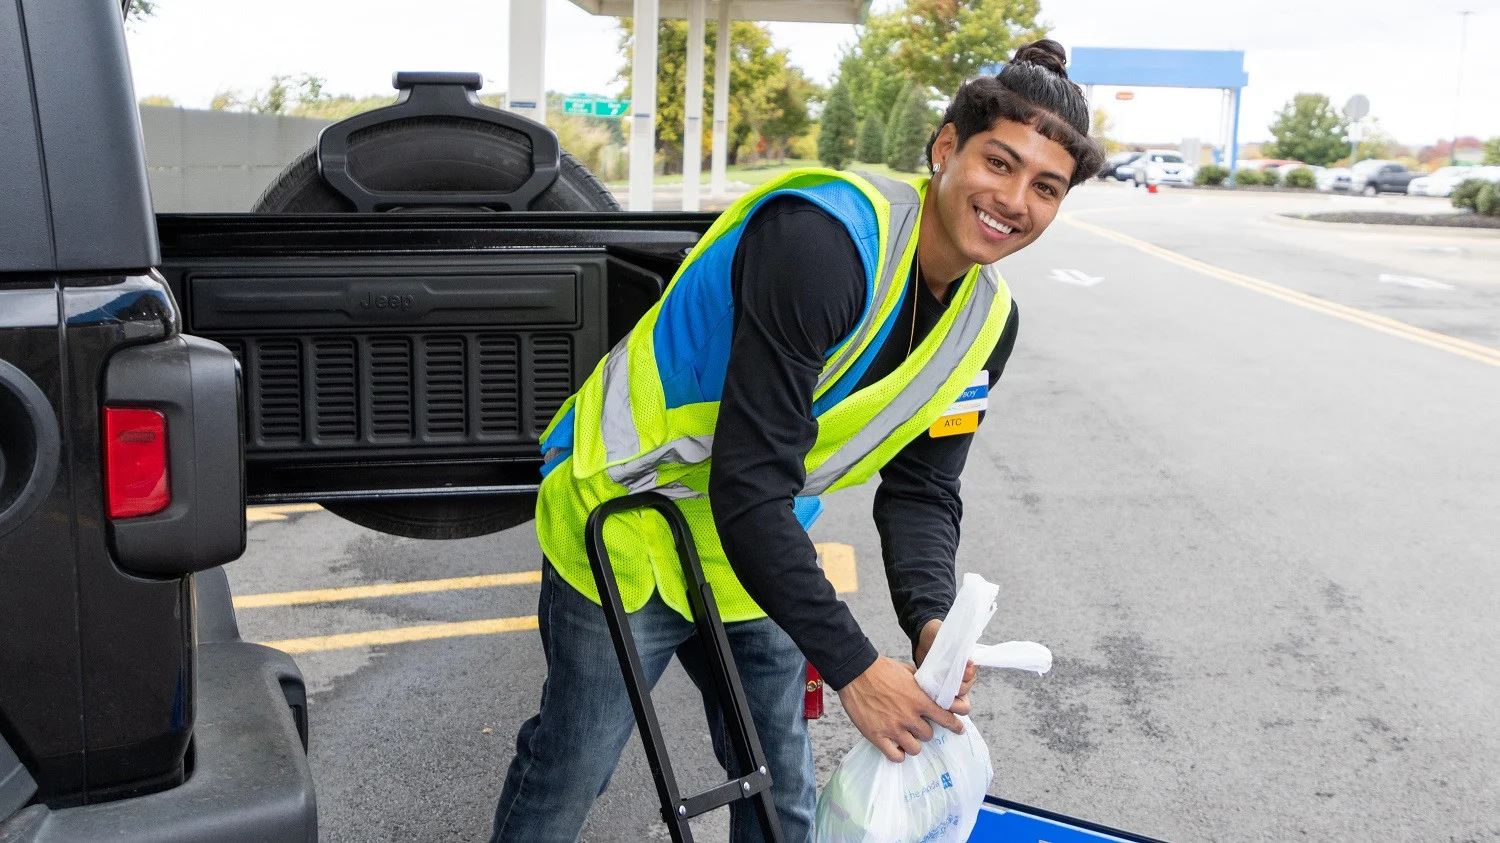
[653,180,881,408]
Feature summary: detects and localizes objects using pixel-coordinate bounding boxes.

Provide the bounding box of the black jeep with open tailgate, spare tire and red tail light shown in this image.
[0,0,713,843]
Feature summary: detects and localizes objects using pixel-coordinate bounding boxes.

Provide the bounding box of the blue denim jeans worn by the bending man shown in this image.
[491,563,818,843]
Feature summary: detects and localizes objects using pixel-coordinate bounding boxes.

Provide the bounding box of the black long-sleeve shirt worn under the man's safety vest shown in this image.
[708,197,1019,689]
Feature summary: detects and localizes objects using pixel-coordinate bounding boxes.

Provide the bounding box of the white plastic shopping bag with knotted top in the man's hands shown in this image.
[816,573,1052,843]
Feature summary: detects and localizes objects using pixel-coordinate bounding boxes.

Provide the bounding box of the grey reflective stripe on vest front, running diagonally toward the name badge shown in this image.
[800,264,1001,495]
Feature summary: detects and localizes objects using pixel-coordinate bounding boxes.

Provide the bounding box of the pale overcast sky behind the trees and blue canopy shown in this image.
[129,0,1500,144]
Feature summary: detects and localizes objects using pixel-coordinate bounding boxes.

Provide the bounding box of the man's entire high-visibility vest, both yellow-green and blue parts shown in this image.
[537,168,1011,623]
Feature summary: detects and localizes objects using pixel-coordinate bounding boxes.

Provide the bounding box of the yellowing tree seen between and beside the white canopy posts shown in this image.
[615,18,788,171]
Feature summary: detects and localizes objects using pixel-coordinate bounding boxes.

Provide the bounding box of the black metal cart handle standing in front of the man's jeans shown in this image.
[585,492,782,843]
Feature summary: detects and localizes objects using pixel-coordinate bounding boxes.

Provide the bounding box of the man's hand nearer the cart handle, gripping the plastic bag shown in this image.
[839,656,963,764]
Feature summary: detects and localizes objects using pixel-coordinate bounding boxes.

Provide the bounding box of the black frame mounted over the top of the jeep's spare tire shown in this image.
[318,71,563,213]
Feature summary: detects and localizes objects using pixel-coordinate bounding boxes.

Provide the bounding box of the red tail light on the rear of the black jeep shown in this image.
[104,407,173,518]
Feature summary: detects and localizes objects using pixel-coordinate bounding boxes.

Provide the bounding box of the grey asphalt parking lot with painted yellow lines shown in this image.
[228,185,1500,842]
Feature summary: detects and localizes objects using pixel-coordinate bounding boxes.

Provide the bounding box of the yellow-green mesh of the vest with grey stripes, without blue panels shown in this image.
[536,170,1011,621]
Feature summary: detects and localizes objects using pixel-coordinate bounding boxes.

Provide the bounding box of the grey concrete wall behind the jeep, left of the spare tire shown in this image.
[141,105,332,213]
